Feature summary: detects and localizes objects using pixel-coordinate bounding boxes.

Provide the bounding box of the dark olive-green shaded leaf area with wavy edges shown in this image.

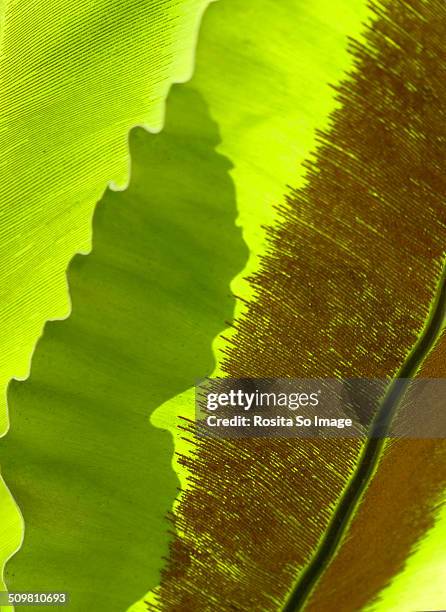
[1,86,247,612]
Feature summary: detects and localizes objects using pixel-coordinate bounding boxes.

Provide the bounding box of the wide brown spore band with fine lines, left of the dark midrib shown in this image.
[152,0,446,612]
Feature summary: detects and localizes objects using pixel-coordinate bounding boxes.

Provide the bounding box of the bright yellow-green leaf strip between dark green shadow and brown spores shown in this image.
[152,0,368,506]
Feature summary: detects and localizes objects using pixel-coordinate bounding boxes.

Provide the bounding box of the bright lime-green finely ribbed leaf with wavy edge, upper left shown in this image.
[0,0,207,433]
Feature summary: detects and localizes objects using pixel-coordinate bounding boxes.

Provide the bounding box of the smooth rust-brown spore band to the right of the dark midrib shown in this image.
[305,332,446,612]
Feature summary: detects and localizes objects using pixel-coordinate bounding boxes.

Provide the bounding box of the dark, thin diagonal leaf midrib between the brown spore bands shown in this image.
[282,262,446,612]
